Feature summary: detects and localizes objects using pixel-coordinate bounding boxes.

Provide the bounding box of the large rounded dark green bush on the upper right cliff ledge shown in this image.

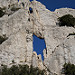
[58,14,75,27]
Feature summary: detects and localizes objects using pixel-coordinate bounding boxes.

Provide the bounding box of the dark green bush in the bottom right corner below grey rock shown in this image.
[63,63,75,75]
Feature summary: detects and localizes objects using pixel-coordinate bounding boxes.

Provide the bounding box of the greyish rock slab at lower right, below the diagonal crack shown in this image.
[44,36,75,75]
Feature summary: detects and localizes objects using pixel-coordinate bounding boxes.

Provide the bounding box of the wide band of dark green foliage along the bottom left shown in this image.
[0,65,46,75]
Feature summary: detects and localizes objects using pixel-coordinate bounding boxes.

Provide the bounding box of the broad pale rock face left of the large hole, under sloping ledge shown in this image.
[0,1,33,65]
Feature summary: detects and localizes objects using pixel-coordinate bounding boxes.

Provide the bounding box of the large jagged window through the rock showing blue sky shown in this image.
[33,35,46,60]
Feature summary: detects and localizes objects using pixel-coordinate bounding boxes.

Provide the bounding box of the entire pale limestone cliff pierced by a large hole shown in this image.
[0,0,75,75]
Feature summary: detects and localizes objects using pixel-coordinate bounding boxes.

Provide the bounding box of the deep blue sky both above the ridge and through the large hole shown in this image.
[31,0,75,59]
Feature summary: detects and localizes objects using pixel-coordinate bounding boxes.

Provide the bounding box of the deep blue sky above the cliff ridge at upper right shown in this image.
[30,0,75,11]
